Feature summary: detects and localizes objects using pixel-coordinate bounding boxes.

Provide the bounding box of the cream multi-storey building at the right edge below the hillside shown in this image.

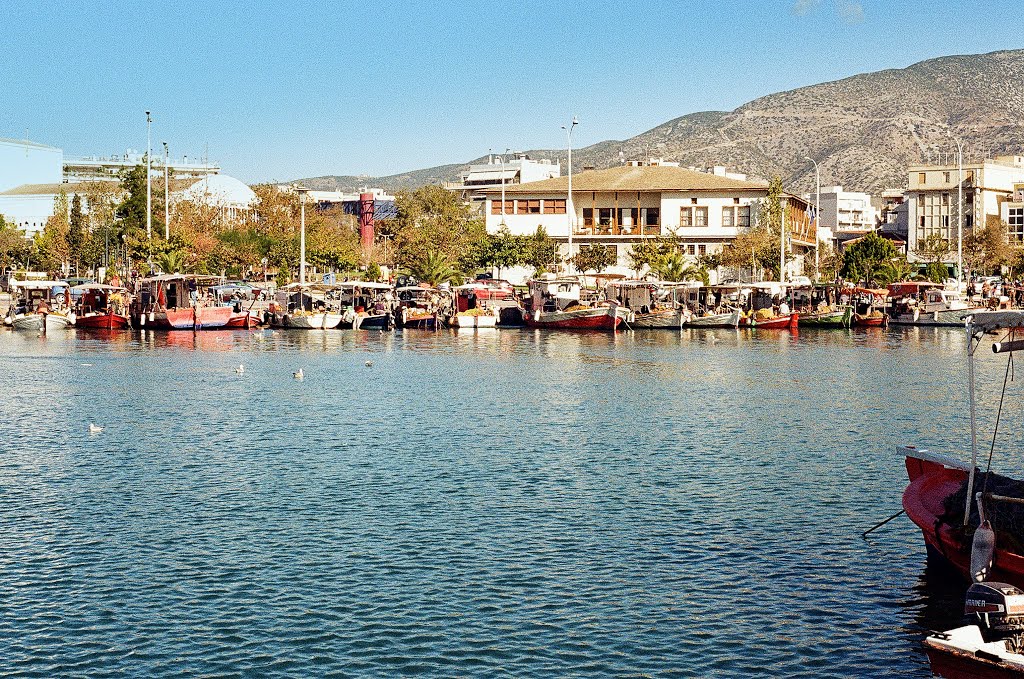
[906,156,1024,263]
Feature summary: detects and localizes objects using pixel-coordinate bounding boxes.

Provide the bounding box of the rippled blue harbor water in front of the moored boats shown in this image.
[0,329,1020,677]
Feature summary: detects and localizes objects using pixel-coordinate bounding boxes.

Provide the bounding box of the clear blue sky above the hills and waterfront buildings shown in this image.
[0,0,1024,181]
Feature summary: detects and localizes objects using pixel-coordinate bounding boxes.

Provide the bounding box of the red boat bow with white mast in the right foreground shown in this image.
[909,311,1024,587]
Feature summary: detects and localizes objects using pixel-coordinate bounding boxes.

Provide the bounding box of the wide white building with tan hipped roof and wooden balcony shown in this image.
[484,164,814,282]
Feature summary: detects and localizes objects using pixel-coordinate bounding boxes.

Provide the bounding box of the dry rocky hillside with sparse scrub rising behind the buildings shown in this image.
[304,50,1024,192]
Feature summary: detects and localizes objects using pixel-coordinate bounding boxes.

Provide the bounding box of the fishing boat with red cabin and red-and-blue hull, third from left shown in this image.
[131,273,231,330]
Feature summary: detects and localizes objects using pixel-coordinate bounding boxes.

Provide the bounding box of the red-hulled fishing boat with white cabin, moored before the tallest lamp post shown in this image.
[525,277,624,331]
